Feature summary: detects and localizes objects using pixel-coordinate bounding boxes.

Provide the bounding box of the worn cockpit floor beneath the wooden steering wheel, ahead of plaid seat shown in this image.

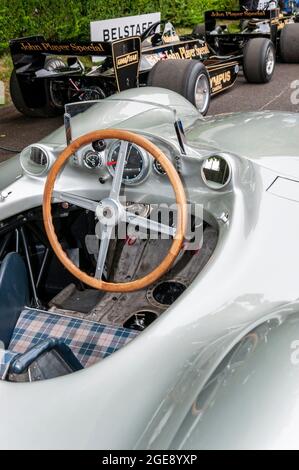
[49,226,218,326]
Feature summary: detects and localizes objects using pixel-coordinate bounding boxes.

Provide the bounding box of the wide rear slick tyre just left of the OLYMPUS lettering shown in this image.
[147,59,211,115]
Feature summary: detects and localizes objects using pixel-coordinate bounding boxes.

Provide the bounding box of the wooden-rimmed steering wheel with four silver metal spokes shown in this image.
[43,129,187,292]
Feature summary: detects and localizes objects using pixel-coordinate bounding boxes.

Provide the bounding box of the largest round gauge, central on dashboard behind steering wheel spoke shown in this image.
[107,142,149,184]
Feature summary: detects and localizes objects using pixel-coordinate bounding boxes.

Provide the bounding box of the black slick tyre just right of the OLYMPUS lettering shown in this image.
[243,38,276,83]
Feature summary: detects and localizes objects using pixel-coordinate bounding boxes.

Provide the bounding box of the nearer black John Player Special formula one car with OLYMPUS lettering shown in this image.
[10,23,275,117]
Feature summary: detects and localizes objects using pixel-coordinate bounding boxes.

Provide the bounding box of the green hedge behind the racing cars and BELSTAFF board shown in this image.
[0,0,238,52]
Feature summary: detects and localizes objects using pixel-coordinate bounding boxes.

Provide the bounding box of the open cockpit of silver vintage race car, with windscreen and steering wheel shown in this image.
[0,92,239,381]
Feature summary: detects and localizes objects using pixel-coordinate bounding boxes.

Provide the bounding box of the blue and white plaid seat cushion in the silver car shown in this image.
[8,309,138,367]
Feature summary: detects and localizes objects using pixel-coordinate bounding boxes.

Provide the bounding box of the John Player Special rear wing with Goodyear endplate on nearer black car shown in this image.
[9,36,141,91]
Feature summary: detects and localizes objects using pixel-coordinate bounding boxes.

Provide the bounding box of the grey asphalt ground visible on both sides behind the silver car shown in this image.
[0,64,299,162]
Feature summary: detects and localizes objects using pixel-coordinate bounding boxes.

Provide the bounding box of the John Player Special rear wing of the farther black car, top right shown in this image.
[205,8,280,34]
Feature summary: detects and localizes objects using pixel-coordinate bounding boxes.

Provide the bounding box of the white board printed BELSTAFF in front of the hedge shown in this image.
[90,13,161,41]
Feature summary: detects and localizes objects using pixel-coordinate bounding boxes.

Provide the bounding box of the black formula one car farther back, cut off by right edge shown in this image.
[193,0,299,73]
